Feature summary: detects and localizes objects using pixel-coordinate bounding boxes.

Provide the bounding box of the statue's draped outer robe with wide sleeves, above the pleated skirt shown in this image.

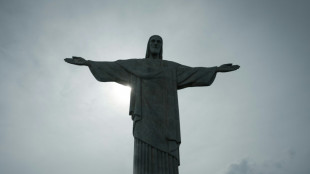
[89,59,216,173]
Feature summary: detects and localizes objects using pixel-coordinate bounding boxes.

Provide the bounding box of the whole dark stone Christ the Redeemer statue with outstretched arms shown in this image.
[65,35,239,174]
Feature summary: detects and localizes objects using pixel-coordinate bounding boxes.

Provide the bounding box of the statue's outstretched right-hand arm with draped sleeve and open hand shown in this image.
[177,64,240,89]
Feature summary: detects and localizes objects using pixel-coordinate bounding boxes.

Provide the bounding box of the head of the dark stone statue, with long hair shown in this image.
[145,35,163,59]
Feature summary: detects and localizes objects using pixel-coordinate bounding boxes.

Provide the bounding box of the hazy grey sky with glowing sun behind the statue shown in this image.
[0,0,310,174]
